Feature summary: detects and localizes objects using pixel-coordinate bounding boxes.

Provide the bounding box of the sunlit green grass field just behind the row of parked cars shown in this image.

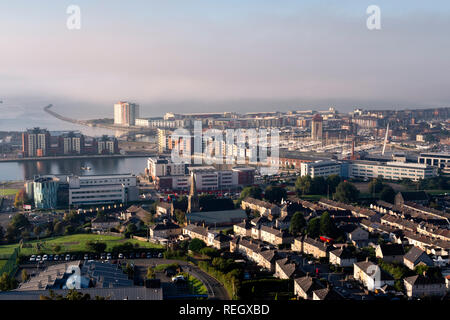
[0,234,163,255]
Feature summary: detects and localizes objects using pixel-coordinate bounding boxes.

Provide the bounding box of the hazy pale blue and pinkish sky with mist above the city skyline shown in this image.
[0,0,450,118]
